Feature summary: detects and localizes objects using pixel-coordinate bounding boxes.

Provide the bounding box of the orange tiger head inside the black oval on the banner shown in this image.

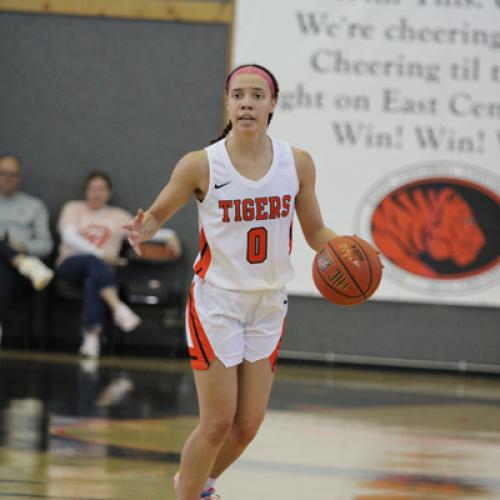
[372,182,487,278]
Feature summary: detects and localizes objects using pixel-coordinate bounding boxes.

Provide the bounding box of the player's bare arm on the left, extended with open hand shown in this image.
[123,150,209,255]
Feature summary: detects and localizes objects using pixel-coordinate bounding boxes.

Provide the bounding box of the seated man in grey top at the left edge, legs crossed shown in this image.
[0,155,54,340]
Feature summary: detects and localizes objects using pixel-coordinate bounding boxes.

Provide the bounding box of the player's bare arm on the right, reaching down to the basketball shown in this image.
[293,148,338,251]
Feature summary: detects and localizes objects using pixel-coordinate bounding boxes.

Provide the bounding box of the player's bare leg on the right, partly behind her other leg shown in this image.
[210,358,274,478]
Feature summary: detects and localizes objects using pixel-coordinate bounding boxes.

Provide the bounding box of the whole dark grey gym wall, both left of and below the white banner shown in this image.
[0,2,500,372]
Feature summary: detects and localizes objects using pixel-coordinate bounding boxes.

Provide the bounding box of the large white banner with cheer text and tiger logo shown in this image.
[233,0,500,306]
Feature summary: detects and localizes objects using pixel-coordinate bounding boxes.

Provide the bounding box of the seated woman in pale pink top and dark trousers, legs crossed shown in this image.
[56,171,141,357]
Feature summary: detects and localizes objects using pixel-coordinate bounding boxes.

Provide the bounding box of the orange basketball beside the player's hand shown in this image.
[313,236,384,306]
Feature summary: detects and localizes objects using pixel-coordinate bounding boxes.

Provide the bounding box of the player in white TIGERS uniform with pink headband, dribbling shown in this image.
[124,65,336,500]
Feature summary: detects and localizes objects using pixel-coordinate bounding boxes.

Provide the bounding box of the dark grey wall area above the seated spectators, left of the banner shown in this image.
[0,9,228,256]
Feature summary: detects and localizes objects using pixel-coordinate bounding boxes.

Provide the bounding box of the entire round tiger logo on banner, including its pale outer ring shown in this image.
[355,162,500,292]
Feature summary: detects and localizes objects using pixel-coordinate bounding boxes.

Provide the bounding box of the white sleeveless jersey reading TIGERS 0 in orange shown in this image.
[194,139,299,291]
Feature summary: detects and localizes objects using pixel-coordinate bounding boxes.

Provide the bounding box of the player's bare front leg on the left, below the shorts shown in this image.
[176,359,238,500]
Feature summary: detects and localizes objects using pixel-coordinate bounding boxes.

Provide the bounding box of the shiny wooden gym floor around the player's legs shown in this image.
[0,351,500,500]
